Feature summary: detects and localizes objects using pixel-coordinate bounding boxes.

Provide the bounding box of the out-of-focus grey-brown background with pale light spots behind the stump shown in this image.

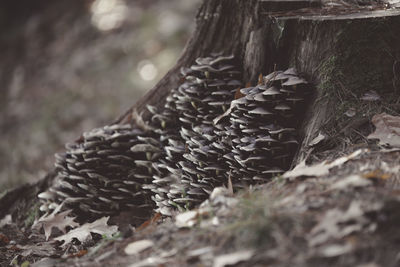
[0,0,200,192]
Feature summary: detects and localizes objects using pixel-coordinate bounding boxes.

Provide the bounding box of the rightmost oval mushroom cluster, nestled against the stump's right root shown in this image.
[221,69,311,184]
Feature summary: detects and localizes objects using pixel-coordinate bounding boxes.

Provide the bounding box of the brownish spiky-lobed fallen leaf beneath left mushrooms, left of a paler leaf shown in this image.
[32,203,79,240]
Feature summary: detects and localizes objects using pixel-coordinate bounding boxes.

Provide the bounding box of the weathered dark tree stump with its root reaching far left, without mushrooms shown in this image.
[0,0,400,254]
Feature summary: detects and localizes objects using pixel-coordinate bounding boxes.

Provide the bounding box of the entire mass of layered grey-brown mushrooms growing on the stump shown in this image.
[39,55,311,219]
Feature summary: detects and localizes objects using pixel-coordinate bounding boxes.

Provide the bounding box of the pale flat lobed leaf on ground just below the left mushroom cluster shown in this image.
[54,217,118,247]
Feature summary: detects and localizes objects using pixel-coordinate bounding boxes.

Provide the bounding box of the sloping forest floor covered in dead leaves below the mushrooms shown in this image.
[0,144,400,267]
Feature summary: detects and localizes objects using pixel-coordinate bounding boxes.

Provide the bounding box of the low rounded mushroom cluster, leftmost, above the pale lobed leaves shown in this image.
[39,124,156,221]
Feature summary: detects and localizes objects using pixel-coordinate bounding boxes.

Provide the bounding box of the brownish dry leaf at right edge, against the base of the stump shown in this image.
[367,113,400,147]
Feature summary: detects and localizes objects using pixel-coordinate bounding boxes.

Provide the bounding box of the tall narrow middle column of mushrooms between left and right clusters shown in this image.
[146,55,241,215]
